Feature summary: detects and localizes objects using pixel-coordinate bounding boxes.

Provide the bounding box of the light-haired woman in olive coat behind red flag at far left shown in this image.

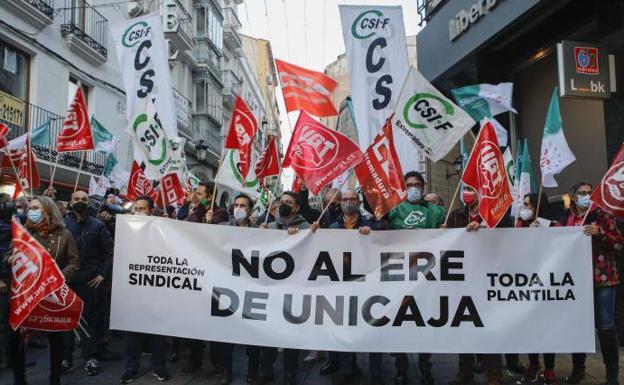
[7,196,79,385]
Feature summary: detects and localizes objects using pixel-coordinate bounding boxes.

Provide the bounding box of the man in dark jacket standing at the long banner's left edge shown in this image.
[62,191,121,376]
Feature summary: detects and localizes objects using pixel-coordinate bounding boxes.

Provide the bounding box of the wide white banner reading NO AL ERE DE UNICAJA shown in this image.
[111,215,594,353]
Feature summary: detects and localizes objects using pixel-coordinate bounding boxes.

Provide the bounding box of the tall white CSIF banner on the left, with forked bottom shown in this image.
[111,13,178,138]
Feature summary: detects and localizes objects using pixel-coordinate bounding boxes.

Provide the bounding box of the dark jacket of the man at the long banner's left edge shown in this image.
[65,213,113,283]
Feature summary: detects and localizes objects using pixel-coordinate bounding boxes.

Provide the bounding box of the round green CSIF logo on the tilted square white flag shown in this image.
[403,93,455,130]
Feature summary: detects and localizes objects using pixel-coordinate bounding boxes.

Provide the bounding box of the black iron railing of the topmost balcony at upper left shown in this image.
[61,0,108,57]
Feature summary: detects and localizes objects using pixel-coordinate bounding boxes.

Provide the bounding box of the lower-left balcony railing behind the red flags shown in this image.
[0,97,106,175]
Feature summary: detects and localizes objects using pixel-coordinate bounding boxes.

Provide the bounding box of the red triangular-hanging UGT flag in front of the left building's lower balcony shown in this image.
[56,84,94,152]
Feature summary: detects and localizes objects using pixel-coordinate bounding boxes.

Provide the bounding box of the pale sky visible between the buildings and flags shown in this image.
[238,0,419,189]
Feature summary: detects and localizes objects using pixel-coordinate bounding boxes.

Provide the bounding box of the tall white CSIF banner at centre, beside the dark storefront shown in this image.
[338,5,419,172]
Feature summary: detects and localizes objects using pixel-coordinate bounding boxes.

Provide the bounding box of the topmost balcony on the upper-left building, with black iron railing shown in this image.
[61,0,108,65]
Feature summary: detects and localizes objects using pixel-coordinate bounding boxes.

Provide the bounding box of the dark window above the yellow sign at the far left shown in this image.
[0,40,30,100]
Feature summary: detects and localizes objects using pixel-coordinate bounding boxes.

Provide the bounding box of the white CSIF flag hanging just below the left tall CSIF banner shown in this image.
[128,98,173,180]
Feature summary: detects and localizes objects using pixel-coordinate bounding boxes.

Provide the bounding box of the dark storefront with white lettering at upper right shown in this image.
[417,0,624,199]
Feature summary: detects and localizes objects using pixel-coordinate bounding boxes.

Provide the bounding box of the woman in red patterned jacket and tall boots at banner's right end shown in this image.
[559,182,624,385]
